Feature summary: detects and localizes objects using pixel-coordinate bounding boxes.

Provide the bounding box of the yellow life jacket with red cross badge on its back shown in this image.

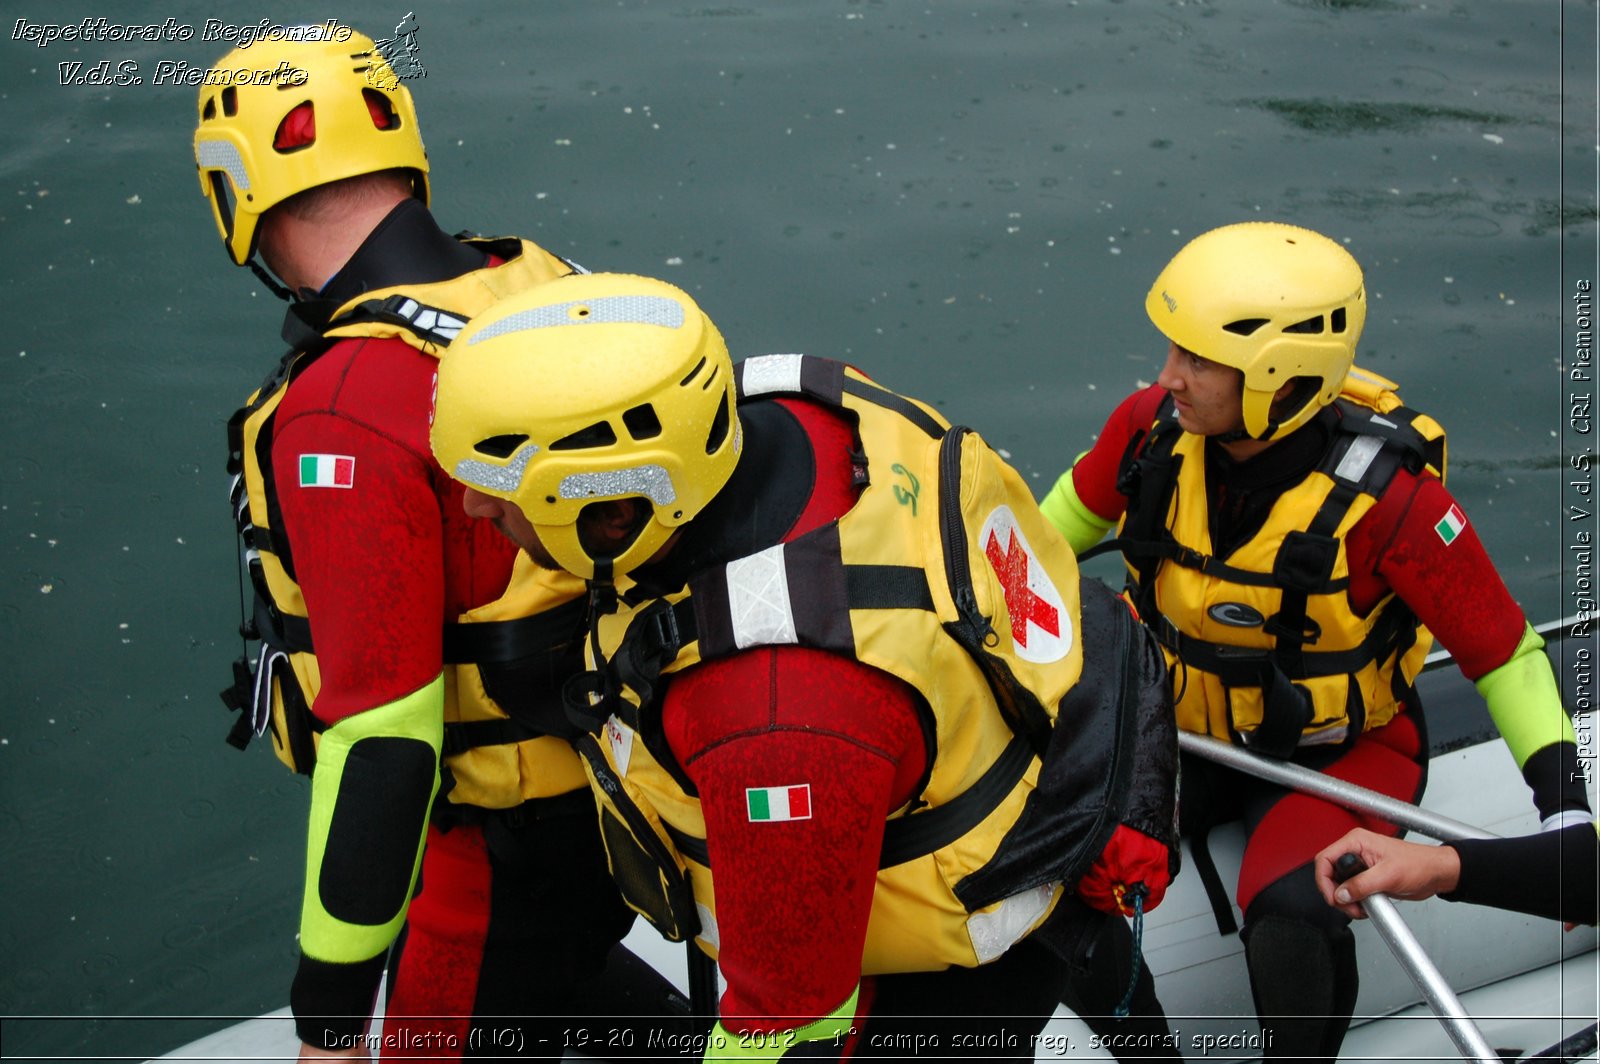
[579,355,1176,974]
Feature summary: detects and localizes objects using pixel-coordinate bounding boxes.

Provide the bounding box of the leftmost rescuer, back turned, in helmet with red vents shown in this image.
[194,27,686,1056]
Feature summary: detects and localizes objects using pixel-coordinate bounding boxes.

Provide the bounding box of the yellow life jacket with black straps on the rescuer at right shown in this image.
[1114,368,1445,757]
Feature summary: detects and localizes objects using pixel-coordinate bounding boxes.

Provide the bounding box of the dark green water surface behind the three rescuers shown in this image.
[0,0,1597,1058]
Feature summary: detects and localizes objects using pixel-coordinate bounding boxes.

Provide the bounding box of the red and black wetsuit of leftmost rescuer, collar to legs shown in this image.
[270,205,669,1056]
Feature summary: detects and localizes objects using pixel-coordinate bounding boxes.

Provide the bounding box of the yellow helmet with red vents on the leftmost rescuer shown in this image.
[195,27,427,266]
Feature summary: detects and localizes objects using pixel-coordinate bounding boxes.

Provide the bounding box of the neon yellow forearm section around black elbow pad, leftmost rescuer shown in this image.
[301,672,445,963]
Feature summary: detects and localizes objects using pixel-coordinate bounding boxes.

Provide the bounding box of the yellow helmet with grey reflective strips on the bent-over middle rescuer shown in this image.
[432,274,741,579]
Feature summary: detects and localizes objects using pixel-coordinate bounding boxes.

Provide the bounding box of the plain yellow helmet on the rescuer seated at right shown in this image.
[1144,222,1366,440]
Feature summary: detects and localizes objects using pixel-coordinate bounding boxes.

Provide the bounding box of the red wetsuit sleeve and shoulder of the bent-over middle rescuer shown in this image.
[662,393,926,1030]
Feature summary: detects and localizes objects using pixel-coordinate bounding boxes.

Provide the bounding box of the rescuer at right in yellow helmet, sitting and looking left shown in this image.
[1042,222,1590,1059]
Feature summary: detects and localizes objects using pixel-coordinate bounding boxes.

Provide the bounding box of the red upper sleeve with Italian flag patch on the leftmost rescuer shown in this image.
[272,339,517,725]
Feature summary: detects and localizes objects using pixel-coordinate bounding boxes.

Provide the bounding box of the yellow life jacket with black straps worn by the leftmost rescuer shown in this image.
[222,238,584,808]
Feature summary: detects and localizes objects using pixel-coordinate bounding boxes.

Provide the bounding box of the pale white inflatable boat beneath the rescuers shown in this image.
[156,674,1600,1062]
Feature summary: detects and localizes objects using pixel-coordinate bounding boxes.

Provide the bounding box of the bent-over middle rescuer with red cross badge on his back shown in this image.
[432,274,1176,1061]
